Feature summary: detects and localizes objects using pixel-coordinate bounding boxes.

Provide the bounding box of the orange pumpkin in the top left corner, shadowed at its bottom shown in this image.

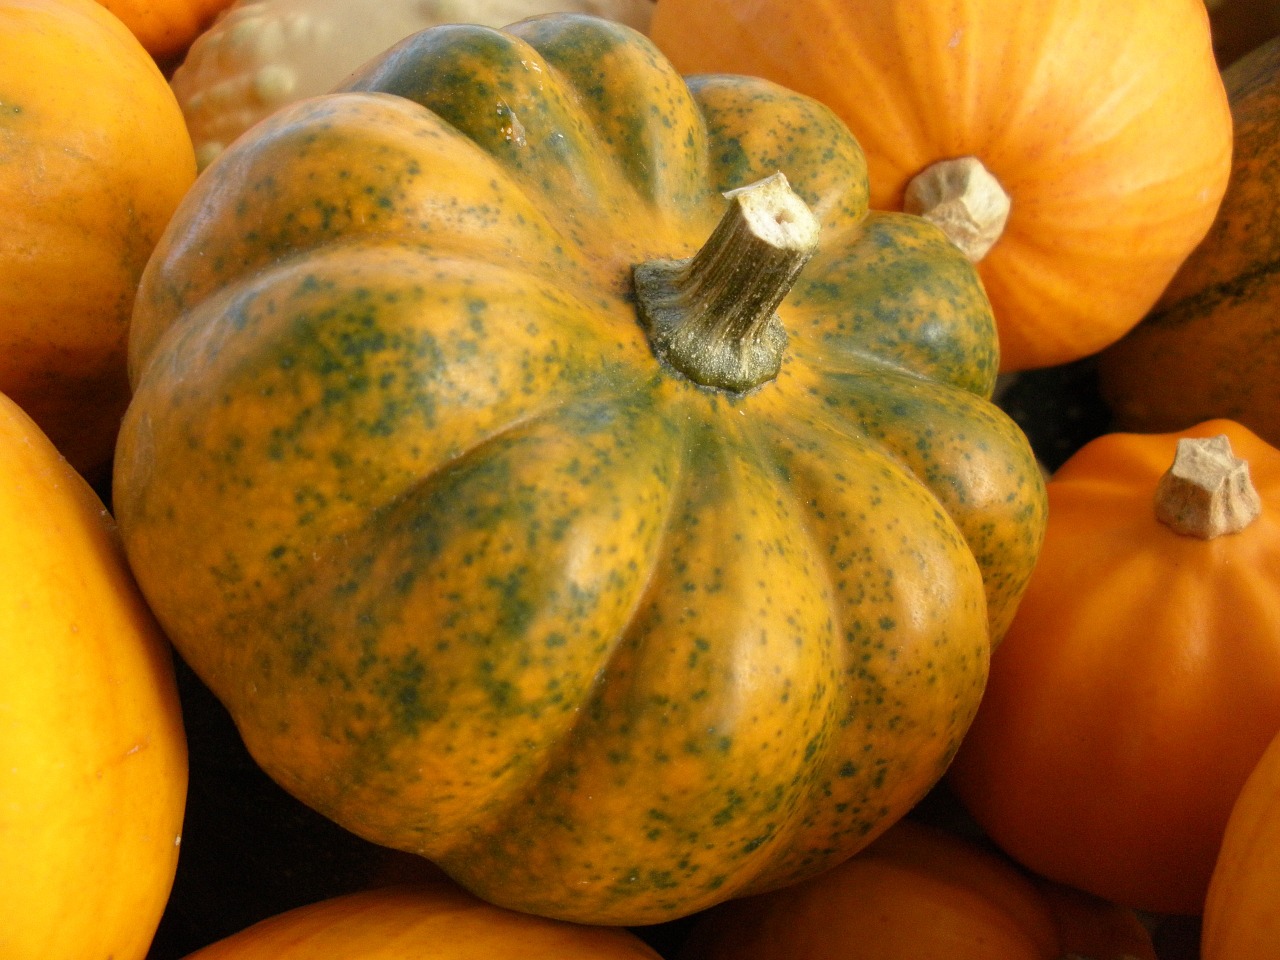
[0,0,196,480]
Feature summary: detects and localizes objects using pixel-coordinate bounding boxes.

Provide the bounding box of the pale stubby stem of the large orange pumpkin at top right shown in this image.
[902,156,1010,264]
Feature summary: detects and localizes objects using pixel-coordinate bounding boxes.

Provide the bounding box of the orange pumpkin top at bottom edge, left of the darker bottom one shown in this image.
[188,879,659,960]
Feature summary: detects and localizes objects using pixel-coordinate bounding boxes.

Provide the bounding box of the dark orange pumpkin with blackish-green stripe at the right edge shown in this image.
[1098,37,1280,444]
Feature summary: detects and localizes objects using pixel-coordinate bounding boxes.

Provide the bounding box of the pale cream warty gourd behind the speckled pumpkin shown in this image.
[170,0,653,169]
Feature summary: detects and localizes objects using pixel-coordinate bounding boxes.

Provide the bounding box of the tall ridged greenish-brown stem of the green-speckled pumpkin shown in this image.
[632,173,819,393]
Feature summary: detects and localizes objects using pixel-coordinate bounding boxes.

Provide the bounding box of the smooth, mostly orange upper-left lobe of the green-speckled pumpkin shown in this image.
[129,91,621,378]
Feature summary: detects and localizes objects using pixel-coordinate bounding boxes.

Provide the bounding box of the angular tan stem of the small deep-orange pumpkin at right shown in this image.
[1156,434,1262,540]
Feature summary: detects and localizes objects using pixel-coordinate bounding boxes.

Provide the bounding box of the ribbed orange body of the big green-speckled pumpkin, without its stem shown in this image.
[114,15,1043,924]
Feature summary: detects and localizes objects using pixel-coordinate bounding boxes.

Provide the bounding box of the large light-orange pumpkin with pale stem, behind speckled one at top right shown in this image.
[650,0,1231,371]
